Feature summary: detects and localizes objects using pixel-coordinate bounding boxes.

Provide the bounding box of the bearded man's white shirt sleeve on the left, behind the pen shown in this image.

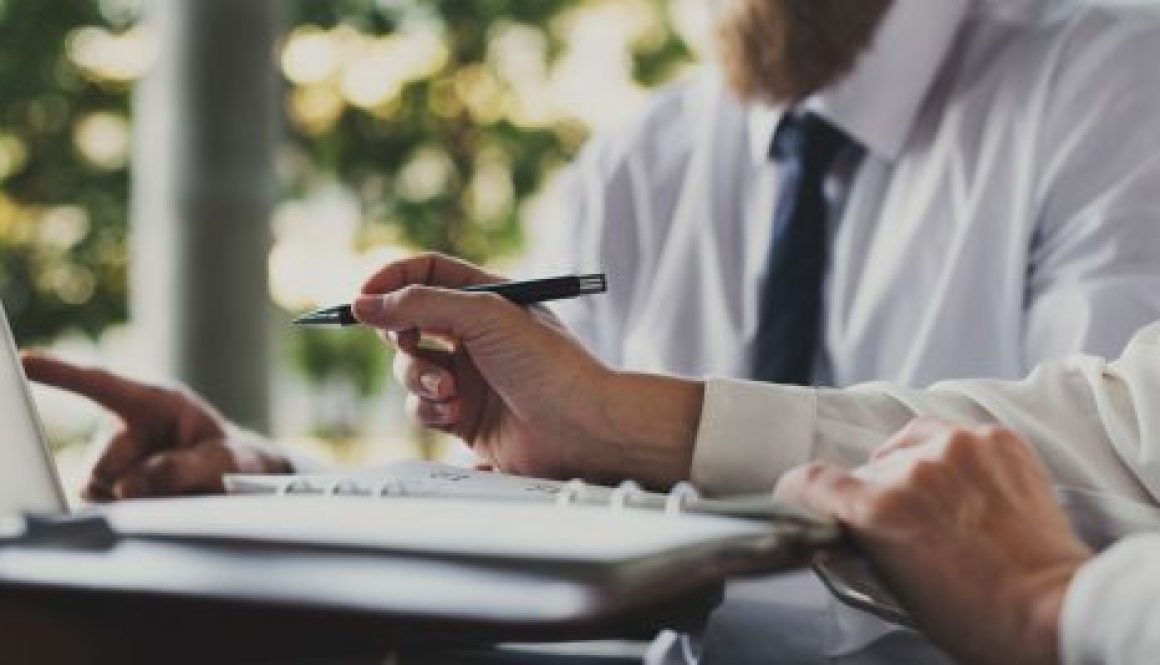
[519,75,716,367]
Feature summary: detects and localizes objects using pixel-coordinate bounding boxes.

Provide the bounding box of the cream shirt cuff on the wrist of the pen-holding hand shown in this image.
[691,380,817,494]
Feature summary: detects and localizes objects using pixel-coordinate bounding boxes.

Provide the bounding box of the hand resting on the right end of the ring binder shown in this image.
[777,420,1092,665]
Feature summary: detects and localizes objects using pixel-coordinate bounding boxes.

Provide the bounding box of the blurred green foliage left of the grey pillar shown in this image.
[0,0,129,344]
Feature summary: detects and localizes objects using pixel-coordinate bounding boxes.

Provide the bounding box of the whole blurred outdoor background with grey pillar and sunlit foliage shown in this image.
[0,0,708,485]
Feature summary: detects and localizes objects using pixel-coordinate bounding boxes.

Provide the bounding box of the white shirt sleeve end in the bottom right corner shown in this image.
[1059,534,1160,665]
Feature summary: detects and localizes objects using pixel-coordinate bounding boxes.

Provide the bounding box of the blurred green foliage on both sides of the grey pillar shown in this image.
[0,0,689,424]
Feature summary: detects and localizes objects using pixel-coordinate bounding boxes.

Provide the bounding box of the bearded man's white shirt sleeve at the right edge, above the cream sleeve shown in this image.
[1023,10,1160,369]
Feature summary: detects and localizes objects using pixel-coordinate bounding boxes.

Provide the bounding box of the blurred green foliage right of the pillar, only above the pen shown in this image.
[290,0,573,262]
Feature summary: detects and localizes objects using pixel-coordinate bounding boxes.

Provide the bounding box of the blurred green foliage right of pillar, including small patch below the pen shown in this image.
[280,0,690,403]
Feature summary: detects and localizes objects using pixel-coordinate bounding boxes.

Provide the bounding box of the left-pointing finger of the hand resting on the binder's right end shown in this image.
[775,462,873,525]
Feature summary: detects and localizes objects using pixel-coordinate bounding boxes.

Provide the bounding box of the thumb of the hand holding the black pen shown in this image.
[354,285,528,344]
